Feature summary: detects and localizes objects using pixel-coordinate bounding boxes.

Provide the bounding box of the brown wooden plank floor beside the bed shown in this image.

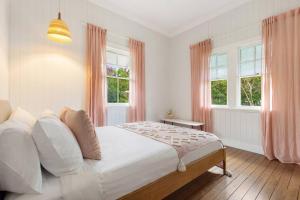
[166,148,300,200]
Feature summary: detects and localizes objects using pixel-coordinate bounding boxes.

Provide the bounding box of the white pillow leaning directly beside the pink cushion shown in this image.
[32,116,83,176]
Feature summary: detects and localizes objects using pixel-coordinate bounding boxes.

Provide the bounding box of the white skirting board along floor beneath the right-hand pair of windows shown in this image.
[221,138,264,155]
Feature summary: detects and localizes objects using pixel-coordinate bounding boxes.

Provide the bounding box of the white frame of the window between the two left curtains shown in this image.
[105,45,132,107]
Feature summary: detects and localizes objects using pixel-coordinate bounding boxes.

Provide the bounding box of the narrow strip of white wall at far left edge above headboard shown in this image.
[0,0,9,99]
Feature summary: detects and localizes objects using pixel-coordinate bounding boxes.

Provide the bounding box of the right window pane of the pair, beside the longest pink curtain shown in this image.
[240,44,262,106]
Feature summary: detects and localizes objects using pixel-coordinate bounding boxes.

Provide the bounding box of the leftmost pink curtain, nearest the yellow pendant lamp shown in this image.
[86,24,106,126]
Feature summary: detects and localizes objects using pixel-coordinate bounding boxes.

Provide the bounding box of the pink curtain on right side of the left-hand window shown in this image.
[128,39,145,122]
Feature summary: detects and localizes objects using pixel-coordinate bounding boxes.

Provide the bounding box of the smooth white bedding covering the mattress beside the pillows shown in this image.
[6,126,223,200]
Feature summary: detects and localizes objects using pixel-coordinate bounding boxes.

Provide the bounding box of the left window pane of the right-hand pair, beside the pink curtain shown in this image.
[210,54,227,105]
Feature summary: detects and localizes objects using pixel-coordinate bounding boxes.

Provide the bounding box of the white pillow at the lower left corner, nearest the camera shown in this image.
[0,121,42,193]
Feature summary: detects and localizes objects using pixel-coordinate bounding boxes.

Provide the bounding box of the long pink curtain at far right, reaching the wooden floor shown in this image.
[261,9,300,164]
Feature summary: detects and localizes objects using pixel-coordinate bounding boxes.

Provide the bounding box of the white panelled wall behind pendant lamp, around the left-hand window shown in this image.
[10,0,169,120]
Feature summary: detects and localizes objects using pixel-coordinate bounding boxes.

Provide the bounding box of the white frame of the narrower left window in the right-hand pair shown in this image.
[209,51,229,108]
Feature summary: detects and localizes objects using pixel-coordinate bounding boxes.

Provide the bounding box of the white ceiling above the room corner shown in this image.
[90,0,249,36]
